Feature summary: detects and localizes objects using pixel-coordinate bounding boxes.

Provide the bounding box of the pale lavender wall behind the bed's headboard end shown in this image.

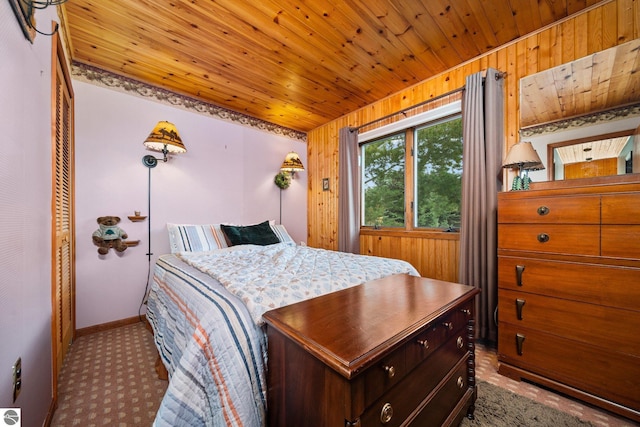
[73,80,307,328]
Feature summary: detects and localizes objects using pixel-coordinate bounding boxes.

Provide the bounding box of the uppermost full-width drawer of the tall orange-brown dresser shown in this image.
[498,256,640,310]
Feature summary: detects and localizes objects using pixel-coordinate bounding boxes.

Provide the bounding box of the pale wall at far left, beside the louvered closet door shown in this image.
[0,1,56,427]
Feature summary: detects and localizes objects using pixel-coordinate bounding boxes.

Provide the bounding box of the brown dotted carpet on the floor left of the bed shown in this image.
[51,323,167,427]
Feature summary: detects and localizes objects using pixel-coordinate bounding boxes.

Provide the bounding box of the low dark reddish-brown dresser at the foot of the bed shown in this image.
[263,275,479,427]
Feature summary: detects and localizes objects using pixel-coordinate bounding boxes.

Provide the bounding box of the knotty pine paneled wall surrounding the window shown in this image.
[307,0,640,280]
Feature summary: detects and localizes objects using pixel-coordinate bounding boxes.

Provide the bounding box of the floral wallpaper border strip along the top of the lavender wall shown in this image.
[71,62,307,142]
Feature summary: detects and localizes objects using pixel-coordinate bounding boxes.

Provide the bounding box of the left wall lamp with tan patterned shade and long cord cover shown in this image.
[142,121,187,263]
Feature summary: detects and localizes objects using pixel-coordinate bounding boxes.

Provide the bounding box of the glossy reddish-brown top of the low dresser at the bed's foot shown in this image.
[263,274,480,378]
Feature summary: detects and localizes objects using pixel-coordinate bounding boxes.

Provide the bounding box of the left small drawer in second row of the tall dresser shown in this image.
[498,224,600,256]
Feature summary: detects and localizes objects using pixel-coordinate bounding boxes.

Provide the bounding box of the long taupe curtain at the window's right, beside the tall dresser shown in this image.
[459,69,504,342]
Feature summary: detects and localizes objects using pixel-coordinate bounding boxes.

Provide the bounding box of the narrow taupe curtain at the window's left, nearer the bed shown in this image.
[338,127,360,254]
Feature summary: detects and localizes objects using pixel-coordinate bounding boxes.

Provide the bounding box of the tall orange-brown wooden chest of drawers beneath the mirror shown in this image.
[498,183,640,421]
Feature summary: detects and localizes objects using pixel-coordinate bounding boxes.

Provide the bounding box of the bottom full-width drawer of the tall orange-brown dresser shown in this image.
[498,322,640,410]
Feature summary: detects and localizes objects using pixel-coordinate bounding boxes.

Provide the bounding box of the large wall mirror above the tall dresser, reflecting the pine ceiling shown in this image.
[520,39,640,182]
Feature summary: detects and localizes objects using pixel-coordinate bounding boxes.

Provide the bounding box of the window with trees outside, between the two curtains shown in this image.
[360,103,462,230]
